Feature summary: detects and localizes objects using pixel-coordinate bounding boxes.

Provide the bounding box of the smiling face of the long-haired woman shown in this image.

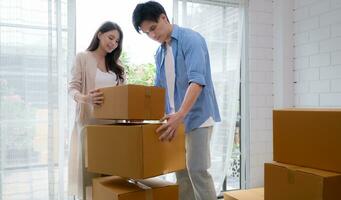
[98,30,120,53]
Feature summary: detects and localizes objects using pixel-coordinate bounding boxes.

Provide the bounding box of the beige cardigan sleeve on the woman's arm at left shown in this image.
[68,54,82,100]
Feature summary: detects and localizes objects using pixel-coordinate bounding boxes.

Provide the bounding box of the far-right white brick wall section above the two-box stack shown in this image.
[294,0,341,107]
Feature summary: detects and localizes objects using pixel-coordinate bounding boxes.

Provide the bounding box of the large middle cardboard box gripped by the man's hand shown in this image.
[85,124,186,179]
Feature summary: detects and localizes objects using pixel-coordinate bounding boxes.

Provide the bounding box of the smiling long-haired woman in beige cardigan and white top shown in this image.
[68,22,125,199]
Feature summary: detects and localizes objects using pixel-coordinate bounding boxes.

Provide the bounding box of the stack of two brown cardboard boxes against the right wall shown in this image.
[264,109,341,200]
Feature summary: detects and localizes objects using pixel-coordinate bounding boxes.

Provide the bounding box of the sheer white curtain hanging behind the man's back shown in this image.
[174,0,244,193]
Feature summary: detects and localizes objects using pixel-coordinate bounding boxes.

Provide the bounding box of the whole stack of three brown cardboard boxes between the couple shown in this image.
[85,85,186,200]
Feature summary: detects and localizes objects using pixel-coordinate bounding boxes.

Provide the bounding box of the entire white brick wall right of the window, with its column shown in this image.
[247,0,341,187]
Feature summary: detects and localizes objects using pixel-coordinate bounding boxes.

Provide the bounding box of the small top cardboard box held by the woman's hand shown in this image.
[93,85,165,120]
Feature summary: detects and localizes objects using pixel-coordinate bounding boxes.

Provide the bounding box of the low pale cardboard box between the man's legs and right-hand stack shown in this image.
[224,188,264,200]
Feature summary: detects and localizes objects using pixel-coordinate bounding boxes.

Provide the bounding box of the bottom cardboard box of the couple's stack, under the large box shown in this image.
[92,176,179,200]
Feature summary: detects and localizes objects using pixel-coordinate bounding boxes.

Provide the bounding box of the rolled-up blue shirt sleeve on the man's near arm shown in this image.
[183,35,207,86]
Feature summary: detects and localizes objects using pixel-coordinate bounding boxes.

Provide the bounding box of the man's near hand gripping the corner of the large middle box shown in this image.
[156,112,184,142]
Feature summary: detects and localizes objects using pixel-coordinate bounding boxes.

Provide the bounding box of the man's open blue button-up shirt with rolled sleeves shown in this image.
[155,25,220,133]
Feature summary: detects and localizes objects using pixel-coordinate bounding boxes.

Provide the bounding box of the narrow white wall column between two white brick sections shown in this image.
[273,0,294,108]
